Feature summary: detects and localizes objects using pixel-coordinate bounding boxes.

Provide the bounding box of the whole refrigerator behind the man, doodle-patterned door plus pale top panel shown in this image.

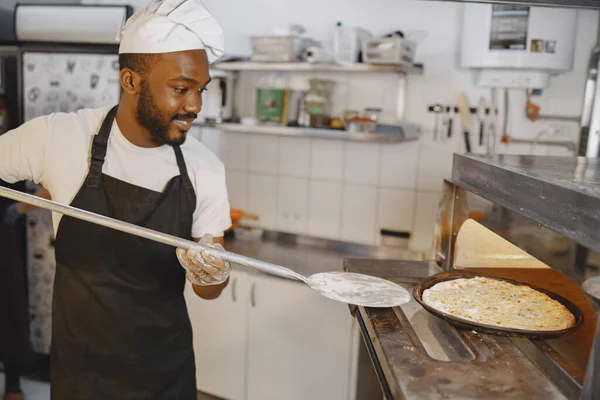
[8,4,132,355]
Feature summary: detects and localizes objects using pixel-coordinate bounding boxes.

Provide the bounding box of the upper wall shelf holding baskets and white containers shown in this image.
[212,62,423,74]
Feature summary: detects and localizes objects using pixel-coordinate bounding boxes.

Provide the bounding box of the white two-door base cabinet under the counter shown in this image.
[186,269,359,400]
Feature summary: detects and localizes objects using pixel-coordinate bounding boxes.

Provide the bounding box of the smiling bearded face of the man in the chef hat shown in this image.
[137,50,210,146]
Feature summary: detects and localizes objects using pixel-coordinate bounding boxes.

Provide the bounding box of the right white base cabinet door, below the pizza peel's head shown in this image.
[247,276,355,400]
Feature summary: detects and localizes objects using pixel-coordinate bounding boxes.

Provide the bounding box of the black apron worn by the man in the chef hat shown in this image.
[51,107,196,400]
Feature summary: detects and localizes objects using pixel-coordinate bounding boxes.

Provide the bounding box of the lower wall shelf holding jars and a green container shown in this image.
[200,123,419,143]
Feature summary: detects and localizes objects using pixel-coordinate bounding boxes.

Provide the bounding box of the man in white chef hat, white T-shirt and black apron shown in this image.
[0,0,231,400]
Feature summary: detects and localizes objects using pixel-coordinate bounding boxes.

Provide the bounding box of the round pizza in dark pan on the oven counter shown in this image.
[423,277,575,331]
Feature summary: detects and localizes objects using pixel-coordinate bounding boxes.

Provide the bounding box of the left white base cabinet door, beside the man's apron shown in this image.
[185,270,249,400]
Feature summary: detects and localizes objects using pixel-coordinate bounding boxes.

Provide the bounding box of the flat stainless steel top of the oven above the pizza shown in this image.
[452,154,600,252]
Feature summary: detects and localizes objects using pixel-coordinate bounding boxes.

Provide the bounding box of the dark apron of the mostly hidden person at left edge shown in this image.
[0,181,35,371]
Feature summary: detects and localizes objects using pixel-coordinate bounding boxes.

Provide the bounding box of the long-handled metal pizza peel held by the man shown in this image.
[0,187,411,307]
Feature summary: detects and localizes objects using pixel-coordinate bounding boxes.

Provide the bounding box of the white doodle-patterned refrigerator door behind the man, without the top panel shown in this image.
[19,45,120,354]
